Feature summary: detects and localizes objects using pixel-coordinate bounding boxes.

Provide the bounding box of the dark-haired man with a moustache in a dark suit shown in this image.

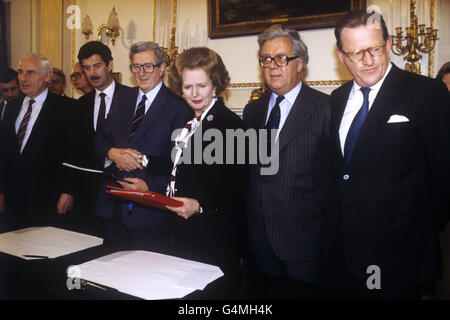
[74,41,126,234]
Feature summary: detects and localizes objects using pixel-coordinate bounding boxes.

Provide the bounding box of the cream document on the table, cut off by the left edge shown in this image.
[0,227,103,260]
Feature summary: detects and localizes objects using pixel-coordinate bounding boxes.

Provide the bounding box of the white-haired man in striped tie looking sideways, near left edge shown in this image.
[0,54,73,227]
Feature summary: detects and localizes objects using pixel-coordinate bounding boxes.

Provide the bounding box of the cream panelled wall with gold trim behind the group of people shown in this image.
[7,0,450,108]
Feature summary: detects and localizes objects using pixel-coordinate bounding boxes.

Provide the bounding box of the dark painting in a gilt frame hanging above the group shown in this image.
[208,0,366,39]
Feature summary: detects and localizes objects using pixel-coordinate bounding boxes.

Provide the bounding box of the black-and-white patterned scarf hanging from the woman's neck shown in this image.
[166,116,201,197]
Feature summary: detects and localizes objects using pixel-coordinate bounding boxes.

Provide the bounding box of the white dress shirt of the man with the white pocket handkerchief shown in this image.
[339,63,392,155]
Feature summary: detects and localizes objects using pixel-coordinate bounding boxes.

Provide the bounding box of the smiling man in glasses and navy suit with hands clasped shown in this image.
[95,42,188,250]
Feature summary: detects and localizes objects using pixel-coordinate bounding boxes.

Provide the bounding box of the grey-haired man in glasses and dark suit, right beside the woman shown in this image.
[244,25,330,282]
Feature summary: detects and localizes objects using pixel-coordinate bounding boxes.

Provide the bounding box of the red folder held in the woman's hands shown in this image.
[106,186,183,210]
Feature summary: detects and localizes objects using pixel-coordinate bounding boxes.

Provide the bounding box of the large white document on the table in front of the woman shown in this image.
[67,251,223,300]
